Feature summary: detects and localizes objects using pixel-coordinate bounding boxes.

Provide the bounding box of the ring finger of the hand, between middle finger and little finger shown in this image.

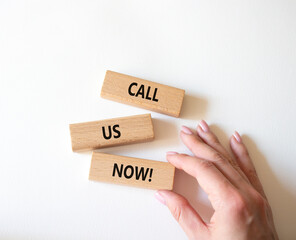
[197,120,249,183]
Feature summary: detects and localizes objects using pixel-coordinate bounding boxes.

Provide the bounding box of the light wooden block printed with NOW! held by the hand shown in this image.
[89,152,175,190]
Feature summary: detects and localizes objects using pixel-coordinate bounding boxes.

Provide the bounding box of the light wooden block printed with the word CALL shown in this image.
[101,71,185,117]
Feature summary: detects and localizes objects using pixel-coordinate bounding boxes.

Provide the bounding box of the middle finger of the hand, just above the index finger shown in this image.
[181,126,248,189]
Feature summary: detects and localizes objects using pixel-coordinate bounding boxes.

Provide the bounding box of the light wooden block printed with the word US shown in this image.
[70,114,154,151]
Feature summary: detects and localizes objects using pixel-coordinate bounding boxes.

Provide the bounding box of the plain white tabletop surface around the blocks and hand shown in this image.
[0,0,296,240]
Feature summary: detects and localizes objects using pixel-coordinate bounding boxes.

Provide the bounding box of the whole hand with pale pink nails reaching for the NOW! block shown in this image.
[155,121,278,240]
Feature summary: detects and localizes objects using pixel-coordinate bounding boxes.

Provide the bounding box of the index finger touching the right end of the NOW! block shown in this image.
[167,152,235,210]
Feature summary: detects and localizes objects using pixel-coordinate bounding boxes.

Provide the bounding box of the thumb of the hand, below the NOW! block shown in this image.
[155,190,208,239]
